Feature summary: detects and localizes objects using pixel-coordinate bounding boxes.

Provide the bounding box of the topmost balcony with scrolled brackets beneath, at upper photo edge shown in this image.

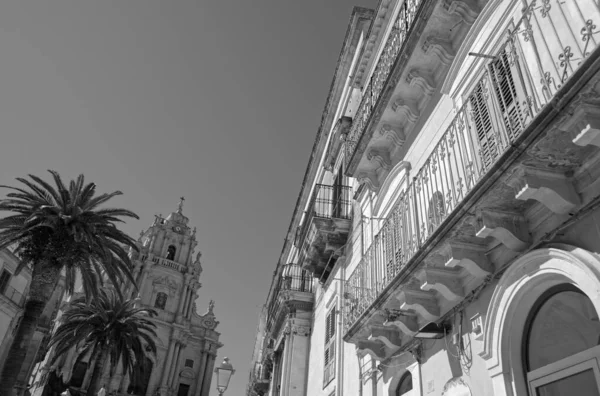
[345,0,487,191]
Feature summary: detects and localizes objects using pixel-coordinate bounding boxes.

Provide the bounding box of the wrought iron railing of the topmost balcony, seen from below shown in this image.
[345,0,422,168]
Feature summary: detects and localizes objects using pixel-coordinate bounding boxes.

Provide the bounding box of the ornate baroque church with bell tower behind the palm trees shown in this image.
[32,200,222,396]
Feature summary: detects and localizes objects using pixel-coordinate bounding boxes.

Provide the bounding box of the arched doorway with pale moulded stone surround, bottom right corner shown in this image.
[480,244,600,396]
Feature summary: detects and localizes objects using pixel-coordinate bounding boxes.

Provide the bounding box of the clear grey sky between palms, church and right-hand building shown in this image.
[0,0,377,395]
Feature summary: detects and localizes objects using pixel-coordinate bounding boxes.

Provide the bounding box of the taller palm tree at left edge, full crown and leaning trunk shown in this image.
[0,171,138,396]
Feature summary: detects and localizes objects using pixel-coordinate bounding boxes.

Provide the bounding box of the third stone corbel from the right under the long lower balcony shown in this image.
[475,208,531,252]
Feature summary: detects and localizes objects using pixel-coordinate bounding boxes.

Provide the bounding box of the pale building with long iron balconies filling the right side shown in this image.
[247,0,600,396]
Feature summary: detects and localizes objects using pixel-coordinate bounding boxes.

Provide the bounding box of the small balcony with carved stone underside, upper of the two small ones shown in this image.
[294,184,352,280]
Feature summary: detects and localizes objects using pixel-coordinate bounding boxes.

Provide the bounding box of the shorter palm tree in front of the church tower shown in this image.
[50,289,156,395]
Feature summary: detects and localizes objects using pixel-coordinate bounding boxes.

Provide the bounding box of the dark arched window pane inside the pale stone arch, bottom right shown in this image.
[523,285,600,396]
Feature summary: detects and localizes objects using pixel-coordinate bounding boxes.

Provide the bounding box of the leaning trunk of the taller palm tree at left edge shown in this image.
[0,262,61,396]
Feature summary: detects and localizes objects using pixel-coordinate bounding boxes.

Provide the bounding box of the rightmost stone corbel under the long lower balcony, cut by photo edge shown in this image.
[562,104,600,147]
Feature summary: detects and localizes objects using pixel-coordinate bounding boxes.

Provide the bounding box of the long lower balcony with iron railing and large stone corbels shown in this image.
[344,0,600,352]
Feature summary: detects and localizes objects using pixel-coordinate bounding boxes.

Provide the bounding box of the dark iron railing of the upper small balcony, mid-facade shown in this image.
[294,184,352,262]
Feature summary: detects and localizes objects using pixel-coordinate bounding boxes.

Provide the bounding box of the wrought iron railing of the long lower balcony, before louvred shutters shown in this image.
[344,0,600,332]
